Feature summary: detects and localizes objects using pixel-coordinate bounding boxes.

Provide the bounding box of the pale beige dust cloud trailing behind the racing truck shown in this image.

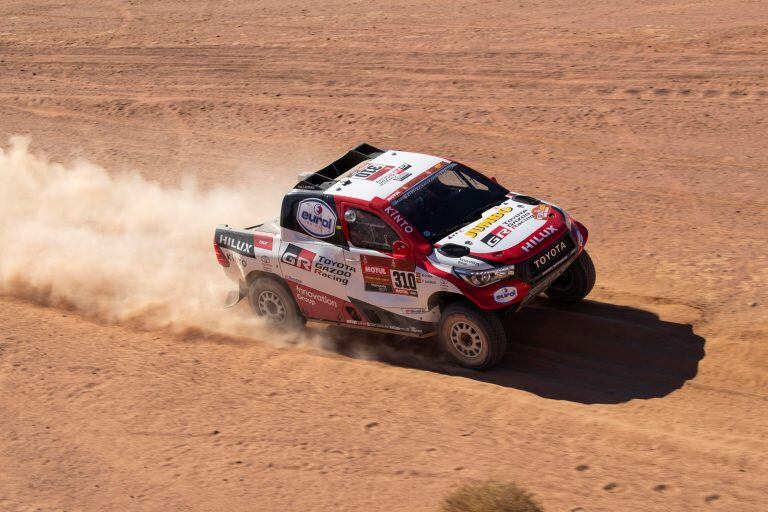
[0,137,304,338]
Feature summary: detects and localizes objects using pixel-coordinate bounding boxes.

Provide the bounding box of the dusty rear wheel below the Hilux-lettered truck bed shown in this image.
[248,277,307,329]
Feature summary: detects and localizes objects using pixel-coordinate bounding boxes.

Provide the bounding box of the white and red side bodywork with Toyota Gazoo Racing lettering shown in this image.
[217,228,460,331]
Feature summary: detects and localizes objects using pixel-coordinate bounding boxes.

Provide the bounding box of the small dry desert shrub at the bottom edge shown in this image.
[442,480,543,512]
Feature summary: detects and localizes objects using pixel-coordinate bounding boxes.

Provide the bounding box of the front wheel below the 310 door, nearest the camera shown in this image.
[437,301,507,370]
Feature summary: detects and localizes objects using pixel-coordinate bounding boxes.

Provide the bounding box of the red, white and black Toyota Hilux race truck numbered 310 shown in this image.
[213,144,595,369]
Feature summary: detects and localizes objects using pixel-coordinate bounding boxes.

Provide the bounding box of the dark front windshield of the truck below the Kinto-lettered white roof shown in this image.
[392,162,509,243]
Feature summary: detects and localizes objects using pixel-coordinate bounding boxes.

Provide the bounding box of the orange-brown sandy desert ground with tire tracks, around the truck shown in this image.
[0,0,768,512]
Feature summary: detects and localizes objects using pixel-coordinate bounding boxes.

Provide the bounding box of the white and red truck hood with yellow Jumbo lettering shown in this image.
[435,196,568,263]
